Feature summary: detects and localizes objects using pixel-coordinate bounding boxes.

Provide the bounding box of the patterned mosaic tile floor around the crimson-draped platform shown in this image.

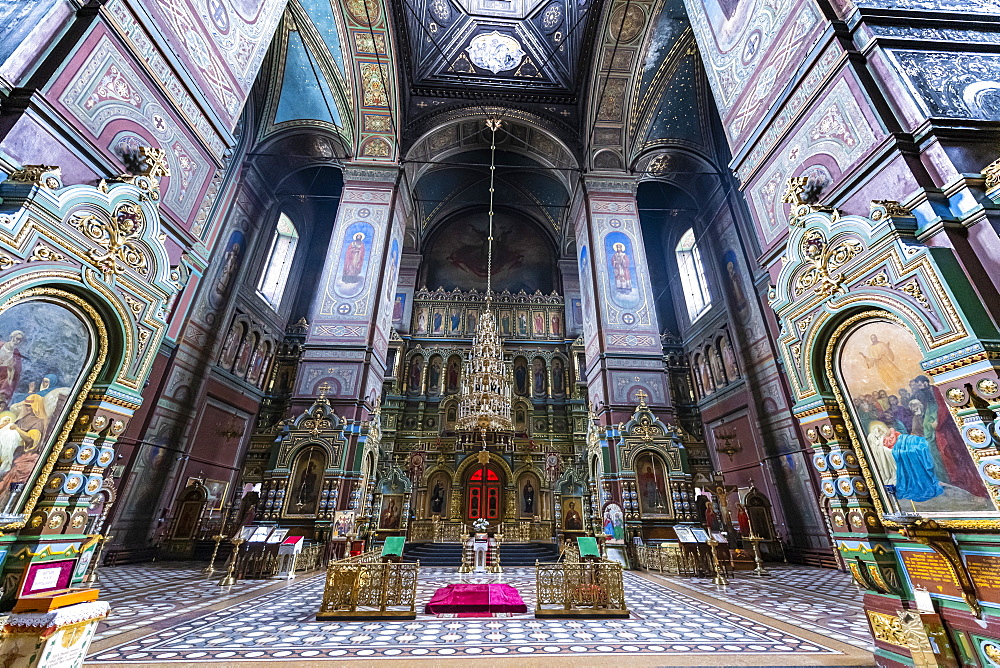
[89,564,872,666]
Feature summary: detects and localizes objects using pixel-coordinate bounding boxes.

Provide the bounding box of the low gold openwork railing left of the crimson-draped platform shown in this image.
[316,552,420,621]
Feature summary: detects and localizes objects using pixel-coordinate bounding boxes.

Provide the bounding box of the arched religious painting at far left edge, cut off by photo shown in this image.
[0,301,94,524]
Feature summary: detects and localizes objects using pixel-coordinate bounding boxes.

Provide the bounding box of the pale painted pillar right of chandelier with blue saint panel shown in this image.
[573,178,673,424]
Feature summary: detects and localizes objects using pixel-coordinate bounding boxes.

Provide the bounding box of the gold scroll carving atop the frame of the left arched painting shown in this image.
[69,202,149,280]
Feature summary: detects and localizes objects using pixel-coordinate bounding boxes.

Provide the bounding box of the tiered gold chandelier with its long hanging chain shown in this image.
[455,118,514,440]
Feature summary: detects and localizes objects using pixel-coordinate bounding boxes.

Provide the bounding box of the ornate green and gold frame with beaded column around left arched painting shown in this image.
[0,160,182,532]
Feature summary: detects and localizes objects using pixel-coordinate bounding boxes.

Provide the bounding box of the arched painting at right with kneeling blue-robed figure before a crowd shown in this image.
[836,320,994,513]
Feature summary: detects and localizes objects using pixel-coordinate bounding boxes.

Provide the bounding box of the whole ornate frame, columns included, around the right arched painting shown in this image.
[769,194,1000,532]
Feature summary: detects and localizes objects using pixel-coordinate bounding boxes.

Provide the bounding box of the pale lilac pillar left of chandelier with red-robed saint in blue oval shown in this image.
[293,166,405,421]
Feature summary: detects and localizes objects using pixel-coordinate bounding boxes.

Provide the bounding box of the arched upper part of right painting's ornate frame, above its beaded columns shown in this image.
[768,201,988,405]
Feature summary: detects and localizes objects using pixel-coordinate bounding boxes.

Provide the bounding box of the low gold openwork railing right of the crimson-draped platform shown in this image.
[535,561,629,618]
